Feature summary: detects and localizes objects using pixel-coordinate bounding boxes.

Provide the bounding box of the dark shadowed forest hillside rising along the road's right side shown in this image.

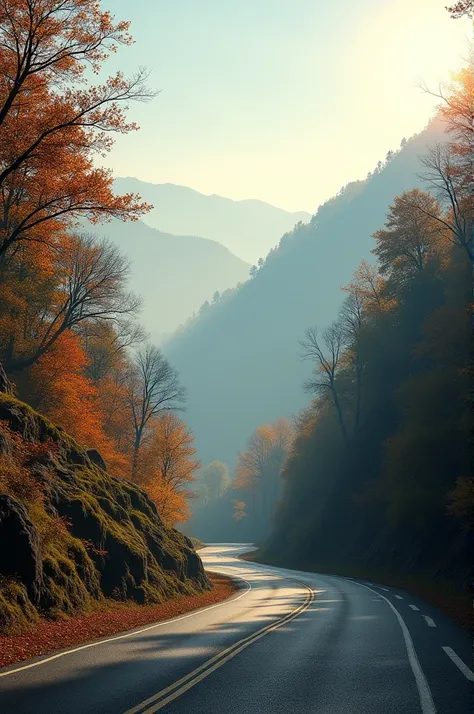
[264,62,474,589]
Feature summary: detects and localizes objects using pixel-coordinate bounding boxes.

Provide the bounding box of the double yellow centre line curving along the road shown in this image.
[124,581,314,714]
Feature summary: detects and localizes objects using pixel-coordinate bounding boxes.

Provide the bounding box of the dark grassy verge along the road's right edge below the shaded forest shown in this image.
[244,550,473,628]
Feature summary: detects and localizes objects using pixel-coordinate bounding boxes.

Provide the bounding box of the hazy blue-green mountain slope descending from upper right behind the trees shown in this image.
[165,119,448,466]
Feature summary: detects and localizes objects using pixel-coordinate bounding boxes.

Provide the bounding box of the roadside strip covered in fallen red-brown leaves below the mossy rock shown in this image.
[0,573,238,667]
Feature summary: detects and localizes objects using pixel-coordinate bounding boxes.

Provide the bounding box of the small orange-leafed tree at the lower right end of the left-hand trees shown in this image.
[137,412,200,525]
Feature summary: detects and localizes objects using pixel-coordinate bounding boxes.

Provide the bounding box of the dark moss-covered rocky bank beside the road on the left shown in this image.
[0,393,210,629]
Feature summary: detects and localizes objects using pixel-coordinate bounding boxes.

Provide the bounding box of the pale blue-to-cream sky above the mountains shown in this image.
[103,0,470,213]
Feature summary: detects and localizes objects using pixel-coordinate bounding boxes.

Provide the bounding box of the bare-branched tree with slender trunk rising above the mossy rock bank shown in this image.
[125,343,186,478]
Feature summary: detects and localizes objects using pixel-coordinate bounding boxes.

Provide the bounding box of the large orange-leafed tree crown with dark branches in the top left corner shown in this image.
[0,0,152,262]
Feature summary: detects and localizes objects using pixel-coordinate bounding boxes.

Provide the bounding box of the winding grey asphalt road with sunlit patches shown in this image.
[0,544,473,714]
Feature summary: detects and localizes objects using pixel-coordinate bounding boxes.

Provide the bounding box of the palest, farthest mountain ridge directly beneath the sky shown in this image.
[115,178,310,263]
